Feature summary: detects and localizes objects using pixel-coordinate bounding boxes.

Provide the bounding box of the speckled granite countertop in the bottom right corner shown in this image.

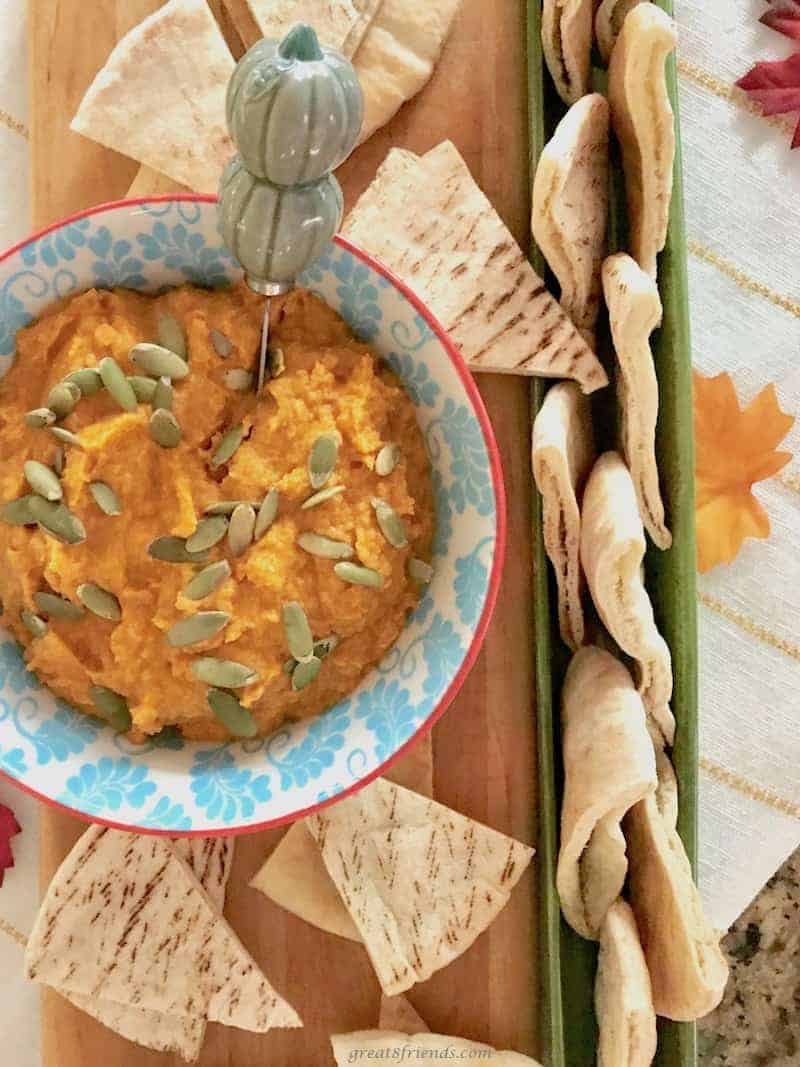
[700,849,800,1067]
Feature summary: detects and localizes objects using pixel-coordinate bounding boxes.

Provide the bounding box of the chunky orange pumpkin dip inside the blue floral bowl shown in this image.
[0,286,433,739]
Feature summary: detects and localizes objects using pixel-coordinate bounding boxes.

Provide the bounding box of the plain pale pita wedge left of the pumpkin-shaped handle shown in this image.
[70,0,235,192]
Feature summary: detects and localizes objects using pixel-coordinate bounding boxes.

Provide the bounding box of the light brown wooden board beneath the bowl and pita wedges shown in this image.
[28,0,539,1067]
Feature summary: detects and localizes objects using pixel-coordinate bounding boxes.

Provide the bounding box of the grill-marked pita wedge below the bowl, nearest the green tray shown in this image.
[307,778,533,997]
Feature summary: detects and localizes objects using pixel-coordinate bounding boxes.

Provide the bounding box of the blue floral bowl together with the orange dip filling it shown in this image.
[0,196,502,833]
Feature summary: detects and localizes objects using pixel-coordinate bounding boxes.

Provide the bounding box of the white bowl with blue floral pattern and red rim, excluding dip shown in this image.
[0,195,505,834]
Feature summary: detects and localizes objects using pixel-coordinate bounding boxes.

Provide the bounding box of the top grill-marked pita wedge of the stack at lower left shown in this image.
[25,826,302,1033]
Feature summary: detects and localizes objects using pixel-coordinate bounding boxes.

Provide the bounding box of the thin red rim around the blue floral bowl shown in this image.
[0,193,507,838]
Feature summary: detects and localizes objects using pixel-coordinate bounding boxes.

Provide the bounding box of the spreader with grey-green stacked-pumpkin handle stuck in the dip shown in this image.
[219,25,364,392]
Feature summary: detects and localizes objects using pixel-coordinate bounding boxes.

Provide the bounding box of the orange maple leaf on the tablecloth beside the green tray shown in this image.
[693,370,795,573]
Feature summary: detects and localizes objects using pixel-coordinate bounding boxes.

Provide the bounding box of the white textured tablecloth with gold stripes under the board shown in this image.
[0,0,800,1067]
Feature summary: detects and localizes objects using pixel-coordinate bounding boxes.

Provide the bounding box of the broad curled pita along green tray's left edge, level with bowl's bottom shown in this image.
[556,646,656,940]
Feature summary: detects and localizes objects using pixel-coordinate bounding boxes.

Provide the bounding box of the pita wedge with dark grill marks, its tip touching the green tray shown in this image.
[342,141,608,393]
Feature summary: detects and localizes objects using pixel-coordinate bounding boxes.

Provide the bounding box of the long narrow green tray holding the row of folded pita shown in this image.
[527,0,698,1067]
